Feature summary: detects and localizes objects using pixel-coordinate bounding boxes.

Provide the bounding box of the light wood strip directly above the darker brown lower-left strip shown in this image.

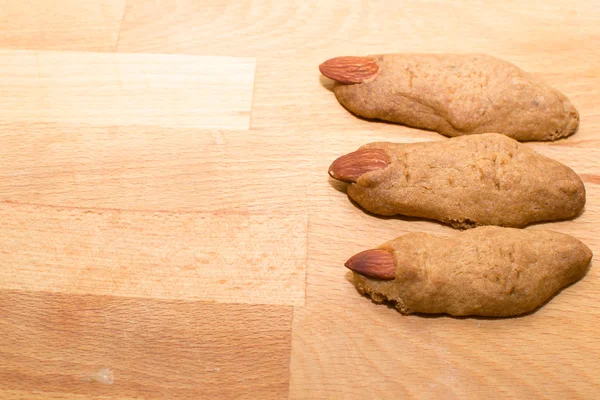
[0,203,306,305]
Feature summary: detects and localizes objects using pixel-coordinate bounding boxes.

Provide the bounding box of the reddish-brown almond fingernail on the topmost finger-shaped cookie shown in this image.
[319,56,379,84]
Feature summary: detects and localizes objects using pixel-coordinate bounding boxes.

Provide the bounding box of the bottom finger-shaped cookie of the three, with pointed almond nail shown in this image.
[346,226,592,317]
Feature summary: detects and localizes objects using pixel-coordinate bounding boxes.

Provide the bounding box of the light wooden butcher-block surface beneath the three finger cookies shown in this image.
[0,0,600,399]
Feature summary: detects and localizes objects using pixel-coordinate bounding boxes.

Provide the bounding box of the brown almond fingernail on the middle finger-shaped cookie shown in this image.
[329,149,391,183]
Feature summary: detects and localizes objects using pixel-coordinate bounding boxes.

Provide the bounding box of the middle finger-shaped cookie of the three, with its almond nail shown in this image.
[329,133,585,229]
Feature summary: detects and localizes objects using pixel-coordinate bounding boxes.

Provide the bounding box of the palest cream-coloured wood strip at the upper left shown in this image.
[0,50,255,129]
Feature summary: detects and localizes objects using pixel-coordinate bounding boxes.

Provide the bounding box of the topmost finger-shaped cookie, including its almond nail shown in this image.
[319,54,579,141]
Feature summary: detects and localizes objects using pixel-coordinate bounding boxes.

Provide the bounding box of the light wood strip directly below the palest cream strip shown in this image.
[0,127,310,216]
